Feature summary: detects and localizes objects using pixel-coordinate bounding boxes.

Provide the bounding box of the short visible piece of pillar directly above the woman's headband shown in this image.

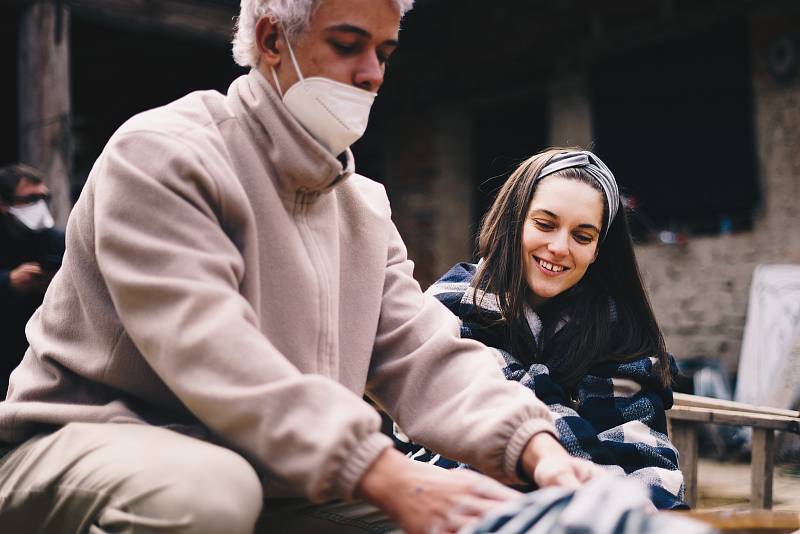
[548,74,592,148]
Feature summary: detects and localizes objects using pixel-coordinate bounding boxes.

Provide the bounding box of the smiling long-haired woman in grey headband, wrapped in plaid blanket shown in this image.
[396,149,685,508]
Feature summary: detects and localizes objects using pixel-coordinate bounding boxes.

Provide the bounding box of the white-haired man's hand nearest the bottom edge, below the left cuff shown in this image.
[357,449,522,534]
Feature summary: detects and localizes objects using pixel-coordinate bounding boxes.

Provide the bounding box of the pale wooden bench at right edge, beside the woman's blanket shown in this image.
[667,393,800,509]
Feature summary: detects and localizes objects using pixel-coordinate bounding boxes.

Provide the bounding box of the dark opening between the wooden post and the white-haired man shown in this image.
[72,17,245,201]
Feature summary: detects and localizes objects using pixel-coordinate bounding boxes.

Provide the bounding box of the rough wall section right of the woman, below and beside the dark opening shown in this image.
[637,9,800,371]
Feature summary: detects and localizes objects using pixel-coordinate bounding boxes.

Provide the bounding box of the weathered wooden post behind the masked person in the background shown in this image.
[18,0,72,228]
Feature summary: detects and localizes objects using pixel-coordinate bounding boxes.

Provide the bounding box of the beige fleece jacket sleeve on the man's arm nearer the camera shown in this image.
[94,132,391,501]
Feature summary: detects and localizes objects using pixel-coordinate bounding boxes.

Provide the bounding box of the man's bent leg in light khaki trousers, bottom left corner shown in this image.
[0,424,262,534]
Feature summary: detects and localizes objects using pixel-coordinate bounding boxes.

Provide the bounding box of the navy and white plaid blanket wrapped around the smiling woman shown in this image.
[394,263,686,509]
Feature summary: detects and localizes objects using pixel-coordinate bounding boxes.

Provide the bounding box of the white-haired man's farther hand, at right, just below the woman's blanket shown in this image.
[520,432,606,489]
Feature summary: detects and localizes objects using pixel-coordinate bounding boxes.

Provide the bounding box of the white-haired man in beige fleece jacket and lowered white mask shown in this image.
[0,0,595,534]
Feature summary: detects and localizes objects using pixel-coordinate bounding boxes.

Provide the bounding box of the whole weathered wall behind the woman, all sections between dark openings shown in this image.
[387,4,800,372]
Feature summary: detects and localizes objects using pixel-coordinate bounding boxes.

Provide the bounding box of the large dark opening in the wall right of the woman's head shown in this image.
[592,21,760,237]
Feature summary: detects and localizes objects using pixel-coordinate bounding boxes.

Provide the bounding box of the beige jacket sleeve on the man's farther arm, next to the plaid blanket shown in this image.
[368,227,554,481]
